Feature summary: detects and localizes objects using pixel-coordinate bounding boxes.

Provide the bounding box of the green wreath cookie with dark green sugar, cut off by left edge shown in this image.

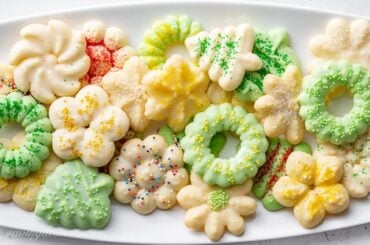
[0,92,53,179]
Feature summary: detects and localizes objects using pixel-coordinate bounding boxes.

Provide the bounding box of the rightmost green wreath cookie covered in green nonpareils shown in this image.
[300,61,370,145]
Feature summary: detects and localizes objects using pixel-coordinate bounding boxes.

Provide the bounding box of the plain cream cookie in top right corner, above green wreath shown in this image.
[310,18,370,70]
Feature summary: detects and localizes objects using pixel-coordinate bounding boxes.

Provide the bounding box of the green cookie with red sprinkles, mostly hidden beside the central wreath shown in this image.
[252,138,312,211]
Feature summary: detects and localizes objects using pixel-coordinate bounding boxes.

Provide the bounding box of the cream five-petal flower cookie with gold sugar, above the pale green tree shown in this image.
[49,85,129,167]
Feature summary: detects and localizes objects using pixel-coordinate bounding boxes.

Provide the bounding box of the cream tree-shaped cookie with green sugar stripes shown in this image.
[185,23,262,91]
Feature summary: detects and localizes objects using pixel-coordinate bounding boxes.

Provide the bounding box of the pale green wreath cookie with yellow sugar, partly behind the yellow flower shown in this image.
[138,15,202,69]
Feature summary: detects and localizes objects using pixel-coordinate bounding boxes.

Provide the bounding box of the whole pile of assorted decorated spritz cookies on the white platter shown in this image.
[0,15,370,240]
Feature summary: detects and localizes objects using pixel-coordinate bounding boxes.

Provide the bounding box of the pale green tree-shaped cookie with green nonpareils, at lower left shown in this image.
[35,160,114,229]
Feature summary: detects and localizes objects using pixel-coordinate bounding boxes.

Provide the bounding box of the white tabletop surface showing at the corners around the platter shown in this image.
[0,0,370,245]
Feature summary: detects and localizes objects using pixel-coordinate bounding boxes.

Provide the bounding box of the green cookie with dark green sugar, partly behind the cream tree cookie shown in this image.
[235,29,300,102]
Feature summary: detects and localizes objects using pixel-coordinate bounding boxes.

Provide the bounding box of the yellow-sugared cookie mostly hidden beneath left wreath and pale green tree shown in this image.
[0,153,62,211]
